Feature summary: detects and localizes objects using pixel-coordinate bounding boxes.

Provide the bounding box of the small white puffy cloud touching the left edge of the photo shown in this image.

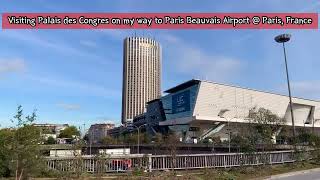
[0,58,26,76]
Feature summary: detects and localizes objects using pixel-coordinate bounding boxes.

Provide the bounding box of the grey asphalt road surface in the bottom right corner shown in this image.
[269,169,320,180]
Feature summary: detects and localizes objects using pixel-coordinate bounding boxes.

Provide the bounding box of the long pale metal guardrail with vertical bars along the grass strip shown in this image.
[45,151,302,173]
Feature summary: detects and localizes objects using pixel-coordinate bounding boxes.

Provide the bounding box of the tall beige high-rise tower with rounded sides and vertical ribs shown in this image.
[121,37,161,123]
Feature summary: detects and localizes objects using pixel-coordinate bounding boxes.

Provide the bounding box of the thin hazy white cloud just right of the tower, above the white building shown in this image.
[161,34,244,81]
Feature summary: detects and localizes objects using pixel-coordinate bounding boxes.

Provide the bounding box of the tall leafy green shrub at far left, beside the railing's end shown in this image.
[0,106,44,180]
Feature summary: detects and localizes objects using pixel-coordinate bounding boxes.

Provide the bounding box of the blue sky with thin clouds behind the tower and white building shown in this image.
[0,0,320,128]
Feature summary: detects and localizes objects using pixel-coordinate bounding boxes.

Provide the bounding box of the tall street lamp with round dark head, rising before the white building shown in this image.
[274,34,296,139]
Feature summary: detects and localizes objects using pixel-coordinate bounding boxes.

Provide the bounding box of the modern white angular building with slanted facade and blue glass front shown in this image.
[159,80,320,141]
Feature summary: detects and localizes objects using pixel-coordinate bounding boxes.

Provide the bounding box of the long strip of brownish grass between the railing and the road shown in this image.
[25,161,320,180]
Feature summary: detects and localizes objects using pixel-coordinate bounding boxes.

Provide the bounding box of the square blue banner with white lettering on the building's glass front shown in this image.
[172,90,190,114]
